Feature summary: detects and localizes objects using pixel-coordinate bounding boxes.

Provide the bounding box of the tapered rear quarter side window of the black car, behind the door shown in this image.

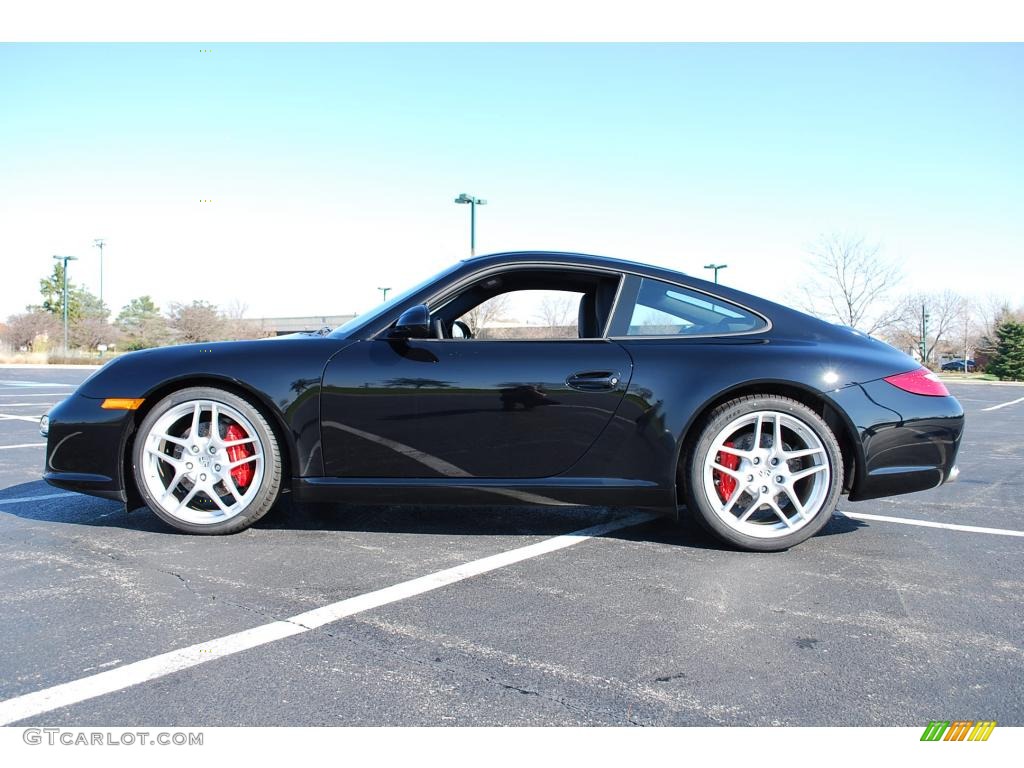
[626,278,765,336]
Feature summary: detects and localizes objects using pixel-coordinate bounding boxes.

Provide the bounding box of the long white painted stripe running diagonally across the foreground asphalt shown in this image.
[0,512,655,725]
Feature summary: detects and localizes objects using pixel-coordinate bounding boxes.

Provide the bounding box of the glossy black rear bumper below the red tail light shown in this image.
[835,380,964,501]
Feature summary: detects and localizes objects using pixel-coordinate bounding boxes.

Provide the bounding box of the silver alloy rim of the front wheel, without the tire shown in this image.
[142,399,265,525]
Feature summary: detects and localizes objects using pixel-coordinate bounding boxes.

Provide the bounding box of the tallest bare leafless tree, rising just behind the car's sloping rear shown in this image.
[797,234,902,334]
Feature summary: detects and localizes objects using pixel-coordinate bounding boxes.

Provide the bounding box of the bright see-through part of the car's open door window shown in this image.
[458,290,584,340]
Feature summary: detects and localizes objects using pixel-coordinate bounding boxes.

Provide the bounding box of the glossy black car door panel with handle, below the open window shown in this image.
[322,303,632,478]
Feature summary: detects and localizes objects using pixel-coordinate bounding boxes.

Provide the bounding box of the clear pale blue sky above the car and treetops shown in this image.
[0,43,1024,316]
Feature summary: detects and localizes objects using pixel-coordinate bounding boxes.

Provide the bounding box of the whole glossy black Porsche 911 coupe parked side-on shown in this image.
[43,252,964,551]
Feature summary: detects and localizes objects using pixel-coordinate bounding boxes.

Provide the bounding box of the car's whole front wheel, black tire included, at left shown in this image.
[132,387,282,535]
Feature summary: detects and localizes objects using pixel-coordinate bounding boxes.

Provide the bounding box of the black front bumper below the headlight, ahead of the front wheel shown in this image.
[43,394,131,502]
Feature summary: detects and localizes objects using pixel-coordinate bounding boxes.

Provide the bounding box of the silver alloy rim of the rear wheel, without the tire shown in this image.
[702,411,831,539]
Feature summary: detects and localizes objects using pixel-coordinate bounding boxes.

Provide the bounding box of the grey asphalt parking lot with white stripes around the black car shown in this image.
[0,368,1024,727]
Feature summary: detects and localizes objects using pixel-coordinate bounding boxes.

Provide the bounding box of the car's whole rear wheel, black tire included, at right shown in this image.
[680,395,843,552]
